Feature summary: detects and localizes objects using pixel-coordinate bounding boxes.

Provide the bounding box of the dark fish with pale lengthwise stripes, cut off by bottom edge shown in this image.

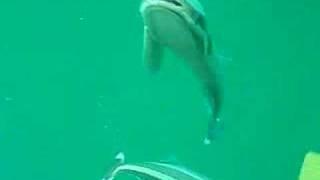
[102,153,210,180]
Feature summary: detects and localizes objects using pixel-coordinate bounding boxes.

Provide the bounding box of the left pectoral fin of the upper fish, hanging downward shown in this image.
[143,26,164,72]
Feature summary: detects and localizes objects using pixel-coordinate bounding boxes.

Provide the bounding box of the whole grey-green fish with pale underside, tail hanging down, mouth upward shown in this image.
[140,0,222,143]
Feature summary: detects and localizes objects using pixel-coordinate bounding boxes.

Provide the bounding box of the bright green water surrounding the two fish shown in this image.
[0,0,320,180]
